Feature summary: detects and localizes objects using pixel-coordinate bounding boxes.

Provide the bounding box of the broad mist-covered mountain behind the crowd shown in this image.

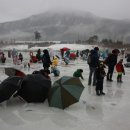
[0,10,130,41]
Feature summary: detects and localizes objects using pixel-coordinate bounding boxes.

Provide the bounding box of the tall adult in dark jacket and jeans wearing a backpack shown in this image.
[88,47,99,86]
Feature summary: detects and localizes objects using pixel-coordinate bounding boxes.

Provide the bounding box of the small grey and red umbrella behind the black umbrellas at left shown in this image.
[5,67,25,77]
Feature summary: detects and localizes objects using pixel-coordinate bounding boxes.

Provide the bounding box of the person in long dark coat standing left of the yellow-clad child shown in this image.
[42,49,52,70]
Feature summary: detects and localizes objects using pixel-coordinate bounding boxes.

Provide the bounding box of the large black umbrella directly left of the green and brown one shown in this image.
[17,74,51,103]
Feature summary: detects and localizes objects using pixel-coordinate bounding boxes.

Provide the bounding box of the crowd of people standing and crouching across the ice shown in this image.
[0,47,128,96]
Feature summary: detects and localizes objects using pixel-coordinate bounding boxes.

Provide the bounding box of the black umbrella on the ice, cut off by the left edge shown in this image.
[0,76,23,103]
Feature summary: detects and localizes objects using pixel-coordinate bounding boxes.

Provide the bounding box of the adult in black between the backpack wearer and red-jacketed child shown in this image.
[105,50,118,81]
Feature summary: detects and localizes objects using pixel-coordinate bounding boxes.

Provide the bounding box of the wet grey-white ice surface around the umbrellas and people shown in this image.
[0,44,130,130]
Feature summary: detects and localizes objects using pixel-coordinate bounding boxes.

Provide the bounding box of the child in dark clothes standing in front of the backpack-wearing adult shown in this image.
[95,62,106,96]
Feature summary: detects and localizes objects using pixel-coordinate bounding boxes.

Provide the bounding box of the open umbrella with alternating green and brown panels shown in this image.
[48,76,84,109]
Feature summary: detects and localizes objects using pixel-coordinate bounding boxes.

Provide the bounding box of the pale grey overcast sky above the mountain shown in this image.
[0,0,130,22]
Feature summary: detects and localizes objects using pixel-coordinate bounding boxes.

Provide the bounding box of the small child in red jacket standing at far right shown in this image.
[116,59,125,82]
